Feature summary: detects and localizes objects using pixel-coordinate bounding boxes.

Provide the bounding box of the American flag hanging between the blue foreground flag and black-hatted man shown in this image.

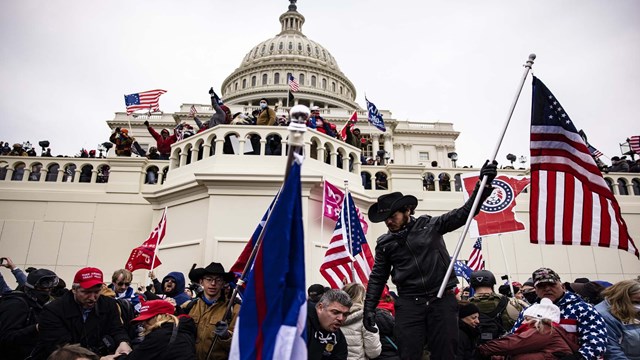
[320,193,373,289]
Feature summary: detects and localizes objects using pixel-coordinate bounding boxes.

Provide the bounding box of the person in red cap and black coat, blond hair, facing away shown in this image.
[101,300,196,360]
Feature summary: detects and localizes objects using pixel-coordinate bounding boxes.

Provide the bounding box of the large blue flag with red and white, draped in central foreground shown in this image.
[229,162,307,360]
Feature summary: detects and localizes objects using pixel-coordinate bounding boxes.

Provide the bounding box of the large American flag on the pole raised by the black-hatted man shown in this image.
[529,77,639,256]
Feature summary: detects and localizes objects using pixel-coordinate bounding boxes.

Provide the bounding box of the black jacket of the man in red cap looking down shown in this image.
[34,291,130,359]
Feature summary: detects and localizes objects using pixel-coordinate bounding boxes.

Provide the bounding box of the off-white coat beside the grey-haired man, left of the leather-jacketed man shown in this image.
[340,304,382,360]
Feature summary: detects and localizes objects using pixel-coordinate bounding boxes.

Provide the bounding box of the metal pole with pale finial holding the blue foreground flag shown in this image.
[205,105,310,360]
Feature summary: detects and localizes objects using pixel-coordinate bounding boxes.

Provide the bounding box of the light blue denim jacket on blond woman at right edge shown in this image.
[596,300,640,360]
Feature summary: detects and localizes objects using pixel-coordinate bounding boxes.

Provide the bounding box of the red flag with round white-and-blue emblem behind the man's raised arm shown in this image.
[462,174,529,238]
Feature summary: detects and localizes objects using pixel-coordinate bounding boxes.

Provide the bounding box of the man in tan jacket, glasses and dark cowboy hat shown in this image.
[184,262,240,360]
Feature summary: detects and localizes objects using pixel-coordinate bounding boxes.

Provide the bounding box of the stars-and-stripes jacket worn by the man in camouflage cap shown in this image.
[511,291,607,360]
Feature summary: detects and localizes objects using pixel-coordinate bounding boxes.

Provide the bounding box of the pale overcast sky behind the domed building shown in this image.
[0,0,640,166]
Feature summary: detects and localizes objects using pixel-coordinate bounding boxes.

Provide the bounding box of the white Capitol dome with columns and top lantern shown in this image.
[222,0,360,110]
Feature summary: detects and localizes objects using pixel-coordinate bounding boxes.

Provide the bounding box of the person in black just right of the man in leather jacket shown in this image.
[456,301,480,360]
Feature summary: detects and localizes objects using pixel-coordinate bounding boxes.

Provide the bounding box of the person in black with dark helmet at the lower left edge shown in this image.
[0,269,58,360]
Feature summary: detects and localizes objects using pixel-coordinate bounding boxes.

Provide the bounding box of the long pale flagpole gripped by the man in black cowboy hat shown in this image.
[438,54,536,298]
